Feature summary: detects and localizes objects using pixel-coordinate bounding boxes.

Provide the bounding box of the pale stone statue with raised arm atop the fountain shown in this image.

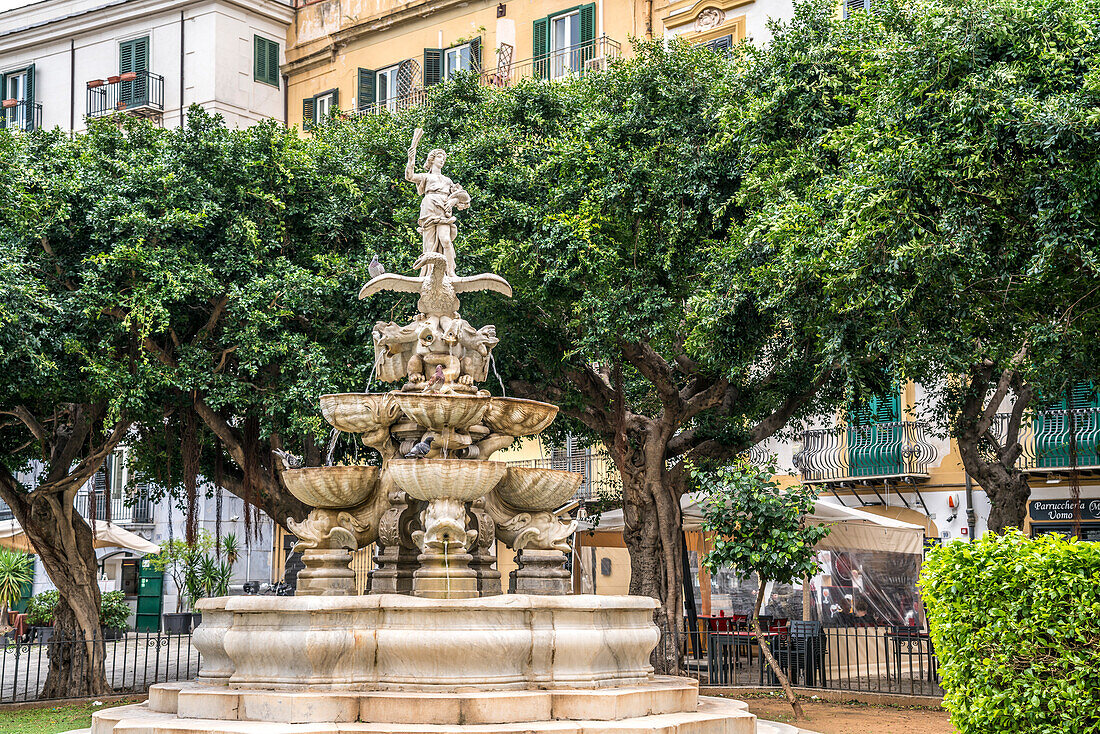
[405,128,470,277]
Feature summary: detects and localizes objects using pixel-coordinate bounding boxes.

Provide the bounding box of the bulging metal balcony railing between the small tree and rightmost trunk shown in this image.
[793,420,936,482]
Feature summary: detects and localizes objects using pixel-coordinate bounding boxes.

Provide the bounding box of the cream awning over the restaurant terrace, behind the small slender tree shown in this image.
[580,494,924,556]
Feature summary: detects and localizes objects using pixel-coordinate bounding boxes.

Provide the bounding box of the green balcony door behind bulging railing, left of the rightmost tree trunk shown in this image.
[847,393,904,476]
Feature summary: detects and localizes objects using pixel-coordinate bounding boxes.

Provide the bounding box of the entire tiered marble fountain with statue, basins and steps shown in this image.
[85,131,756,734]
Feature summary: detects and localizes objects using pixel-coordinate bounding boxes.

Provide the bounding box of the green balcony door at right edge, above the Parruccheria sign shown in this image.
[1034,380,1100,469]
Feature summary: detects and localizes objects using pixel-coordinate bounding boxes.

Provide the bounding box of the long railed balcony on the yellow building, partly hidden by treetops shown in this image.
[355,35,622,116]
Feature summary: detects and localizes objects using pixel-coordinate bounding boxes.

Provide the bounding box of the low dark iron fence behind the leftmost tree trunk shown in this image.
[0,631,199,703]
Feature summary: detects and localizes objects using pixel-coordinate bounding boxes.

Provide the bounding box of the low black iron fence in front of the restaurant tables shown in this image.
[662,621,944,697]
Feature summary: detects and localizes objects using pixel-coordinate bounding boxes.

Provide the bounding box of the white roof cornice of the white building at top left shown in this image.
[0,0,294,53]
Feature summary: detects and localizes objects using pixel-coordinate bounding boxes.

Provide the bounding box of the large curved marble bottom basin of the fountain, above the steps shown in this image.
[194,594,658,691]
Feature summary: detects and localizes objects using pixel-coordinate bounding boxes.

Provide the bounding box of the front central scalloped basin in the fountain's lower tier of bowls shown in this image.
[386,459,508,502]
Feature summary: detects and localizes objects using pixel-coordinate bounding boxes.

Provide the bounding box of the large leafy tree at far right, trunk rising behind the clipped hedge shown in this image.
[732,0,1100,530]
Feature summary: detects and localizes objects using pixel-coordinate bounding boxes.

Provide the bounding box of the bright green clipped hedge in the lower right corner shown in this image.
[921,532,1100,734]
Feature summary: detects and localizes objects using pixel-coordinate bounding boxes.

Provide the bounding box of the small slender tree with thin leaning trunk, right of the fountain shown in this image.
[692,461,829,719]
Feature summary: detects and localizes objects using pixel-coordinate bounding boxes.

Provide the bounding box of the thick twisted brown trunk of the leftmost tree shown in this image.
[17,494,111,698]
